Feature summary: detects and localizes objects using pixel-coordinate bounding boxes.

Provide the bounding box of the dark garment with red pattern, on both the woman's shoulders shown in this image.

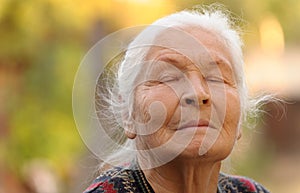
[84,164,269,193]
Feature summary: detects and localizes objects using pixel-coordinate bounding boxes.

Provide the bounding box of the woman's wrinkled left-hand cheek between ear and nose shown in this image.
[133,86,180,149]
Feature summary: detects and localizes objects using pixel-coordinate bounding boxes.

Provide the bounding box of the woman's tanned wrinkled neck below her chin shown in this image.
[144,160,221,193]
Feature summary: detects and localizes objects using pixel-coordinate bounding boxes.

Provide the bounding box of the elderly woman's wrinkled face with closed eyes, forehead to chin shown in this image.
[129,27,241,162]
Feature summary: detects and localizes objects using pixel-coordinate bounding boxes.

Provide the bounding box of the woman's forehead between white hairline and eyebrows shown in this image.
[146,26,232,66]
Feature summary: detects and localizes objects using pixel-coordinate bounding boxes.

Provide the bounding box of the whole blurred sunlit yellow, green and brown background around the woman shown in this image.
[0,0,300,193]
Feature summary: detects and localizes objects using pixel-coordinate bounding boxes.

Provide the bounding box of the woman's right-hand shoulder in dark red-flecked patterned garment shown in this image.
[219,173,269,193]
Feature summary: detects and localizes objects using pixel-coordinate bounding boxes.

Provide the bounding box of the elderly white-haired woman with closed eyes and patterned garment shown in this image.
[85,5,268,193]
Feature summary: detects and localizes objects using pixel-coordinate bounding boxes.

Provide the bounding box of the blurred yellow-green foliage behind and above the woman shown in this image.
[0,0,300,191]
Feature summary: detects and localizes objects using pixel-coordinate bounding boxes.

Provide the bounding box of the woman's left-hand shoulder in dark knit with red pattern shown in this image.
[84,167,135,193]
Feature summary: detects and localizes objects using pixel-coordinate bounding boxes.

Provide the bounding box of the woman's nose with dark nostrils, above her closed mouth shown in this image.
[181,77,210,107]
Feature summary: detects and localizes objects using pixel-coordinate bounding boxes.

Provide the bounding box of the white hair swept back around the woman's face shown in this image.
[96,4,270,170]
